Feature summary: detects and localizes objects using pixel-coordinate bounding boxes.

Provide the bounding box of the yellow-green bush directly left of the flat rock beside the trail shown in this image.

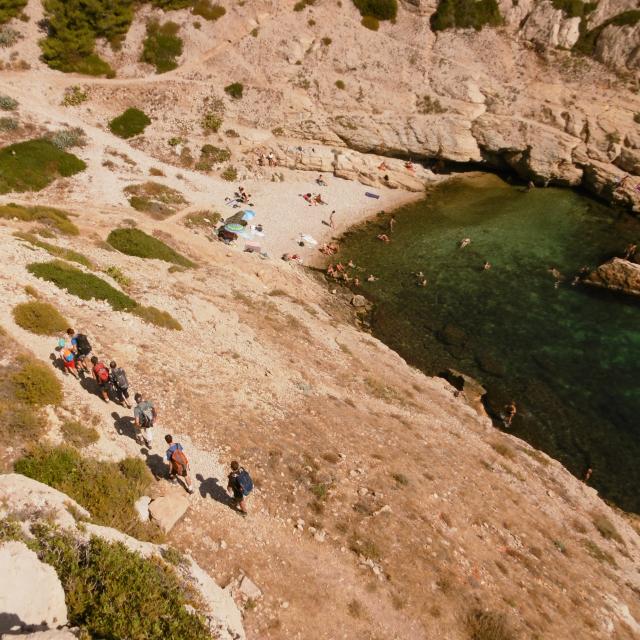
[14,445,158,540]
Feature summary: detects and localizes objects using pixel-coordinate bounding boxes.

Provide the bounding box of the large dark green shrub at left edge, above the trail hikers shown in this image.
[0,139,87,194]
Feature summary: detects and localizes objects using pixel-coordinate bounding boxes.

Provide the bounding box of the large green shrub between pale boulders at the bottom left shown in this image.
[15,523,211,640]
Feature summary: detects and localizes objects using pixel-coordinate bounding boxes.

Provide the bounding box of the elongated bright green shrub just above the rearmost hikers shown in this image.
[27,260,136,311]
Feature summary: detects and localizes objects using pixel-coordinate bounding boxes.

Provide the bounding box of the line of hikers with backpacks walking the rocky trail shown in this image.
[57,328,253,516]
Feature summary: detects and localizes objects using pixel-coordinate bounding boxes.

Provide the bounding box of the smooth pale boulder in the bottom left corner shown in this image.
[0,541,67,633]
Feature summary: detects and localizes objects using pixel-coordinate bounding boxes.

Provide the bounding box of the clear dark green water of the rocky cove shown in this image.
[337,176,640,512]
